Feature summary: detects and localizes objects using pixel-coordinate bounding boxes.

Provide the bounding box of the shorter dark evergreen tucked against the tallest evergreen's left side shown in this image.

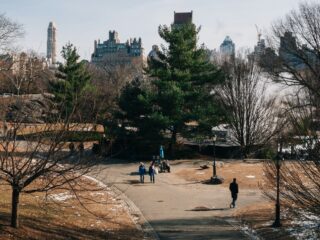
[111,79,166,150]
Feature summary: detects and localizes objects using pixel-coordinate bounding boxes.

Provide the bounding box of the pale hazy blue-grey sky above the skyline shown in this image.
[0,0,308,60]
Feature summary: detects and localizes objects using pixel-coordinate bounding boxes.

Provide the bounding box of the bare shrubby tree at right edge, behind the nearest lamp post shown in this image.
[263,91,320,219]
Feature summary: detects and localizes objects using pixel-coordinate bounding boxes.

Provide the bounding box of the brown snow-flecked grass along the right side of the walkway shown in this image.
[175,160,320,240]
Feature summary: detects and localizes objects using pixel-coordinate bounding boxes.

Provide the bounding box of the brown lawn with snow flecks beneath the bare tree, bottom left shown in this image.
[0,176,143,240]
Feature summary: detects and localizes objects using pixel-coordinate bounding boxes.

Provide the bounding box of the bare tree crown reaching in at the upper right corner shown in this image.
[269,2,320,98]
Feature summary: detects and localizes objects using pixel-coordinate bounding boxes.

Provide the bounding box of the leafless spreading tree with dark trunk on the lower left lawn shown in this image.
[0,99,103,227]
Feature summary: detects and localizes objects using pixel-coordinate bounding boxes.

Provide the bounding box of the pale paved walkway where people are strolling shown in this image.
[91,159,261,240]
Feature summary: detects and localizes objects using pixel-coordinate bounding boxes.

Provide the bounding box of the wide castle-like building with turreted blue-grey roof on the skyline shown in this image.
[91,31,143,66]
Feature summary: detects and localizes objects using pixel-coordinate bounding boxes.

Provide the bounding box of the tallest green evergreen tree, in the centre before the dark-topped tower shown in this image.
[146,24,222,154]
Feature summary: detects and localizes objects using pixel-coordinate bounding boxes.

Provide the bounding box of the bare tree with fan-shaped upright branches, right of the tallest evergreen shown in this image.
[215,53,277,156]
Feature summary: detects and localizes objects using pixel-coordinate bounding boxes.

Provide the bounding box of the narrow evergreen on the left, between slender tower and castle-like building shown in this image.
[49,43,91,120]
